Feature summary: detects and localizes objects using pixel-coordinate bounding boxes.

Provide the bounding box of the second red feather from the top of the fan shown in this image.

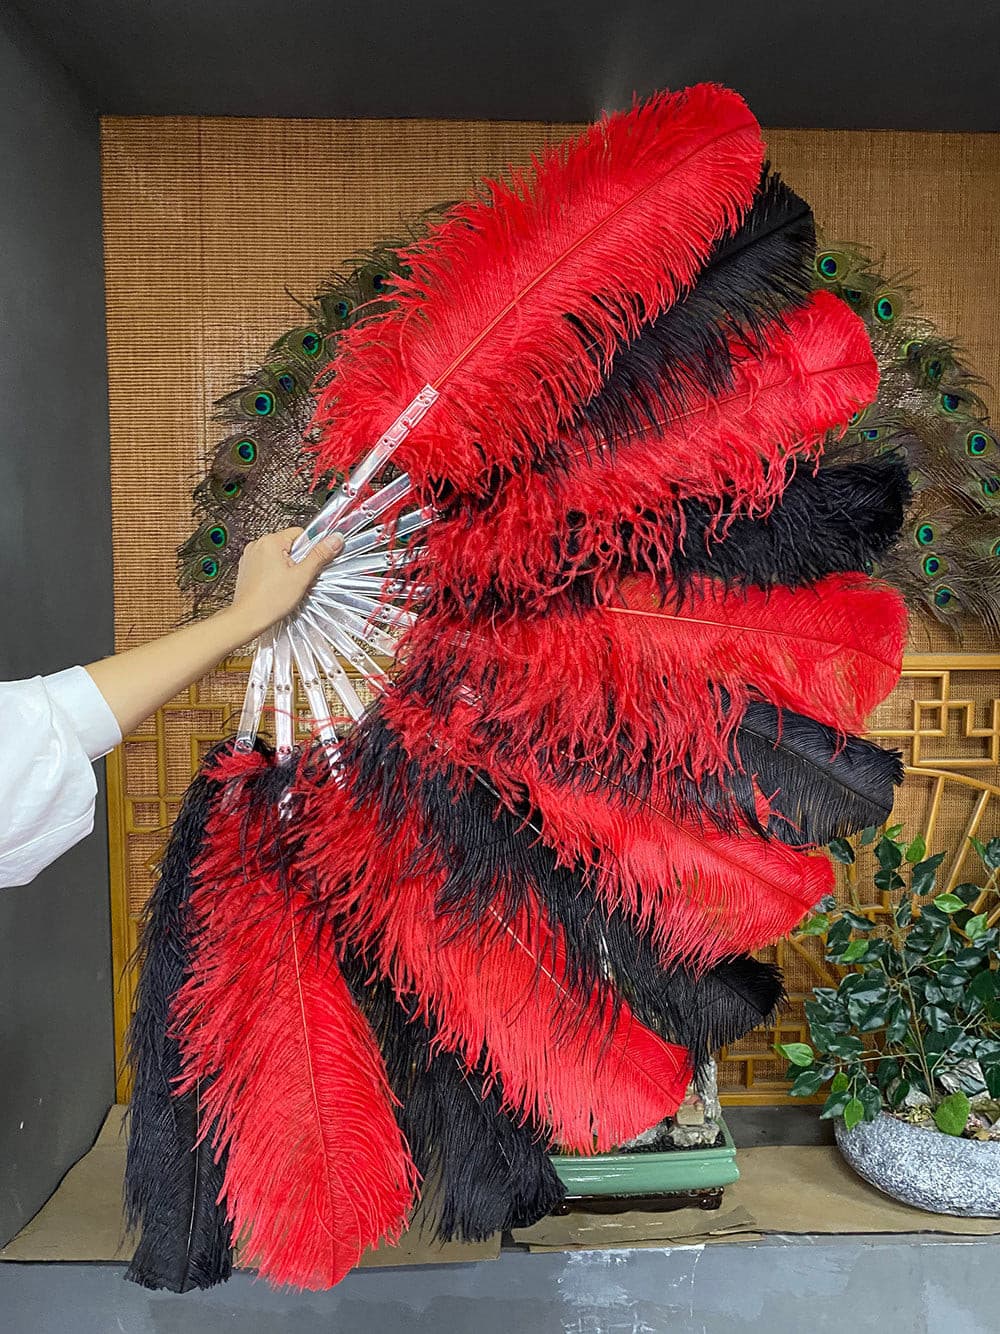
[415,292,879,606]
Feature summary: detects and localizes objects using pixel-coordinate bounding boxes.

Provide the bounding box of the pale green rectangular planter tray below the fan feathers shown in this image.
[552,1122,740,1197]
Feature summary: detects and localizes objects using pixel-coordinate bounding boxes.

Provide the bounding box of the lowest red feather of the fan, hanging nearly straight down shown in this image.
[176,763,416,1289]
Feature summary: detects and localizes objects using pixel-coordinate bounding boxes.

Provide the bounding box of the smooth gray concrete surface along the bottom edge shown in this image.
[0,1237,1000,1334]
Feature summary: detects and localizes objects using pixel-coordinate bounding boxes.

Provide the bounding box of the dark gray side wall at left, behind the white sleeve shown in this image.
[0,11,113,1242]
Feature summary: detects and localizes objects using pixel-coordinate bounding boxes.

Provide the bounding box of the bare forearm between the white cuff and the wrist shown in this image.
[87,606,264,736]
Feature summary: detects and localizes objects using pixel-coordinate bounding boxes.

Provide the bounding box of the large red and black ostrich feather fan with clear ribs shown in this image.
[128,85,909,1290]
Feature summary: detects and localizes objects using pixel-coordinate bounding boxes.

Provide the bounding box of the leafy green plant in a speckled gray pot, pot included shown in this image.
[777,826,1000,1218]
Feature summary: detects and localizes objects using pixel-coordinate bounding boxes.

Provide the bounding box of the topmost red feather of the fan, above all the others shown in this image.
[315,84,763,501]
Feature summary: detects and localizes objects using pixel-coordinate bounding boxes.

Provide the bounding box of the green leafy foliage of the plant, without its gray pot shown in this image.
[794,824,1000,1109]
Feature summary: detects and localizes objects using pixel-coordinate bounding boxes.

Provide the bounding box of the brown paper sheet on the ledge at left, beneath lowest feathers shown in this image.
[0,1107,500,1269]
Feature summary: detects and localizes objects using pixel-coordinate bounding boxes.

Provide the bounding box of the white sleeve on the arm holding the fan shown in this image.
[0,667,121,887]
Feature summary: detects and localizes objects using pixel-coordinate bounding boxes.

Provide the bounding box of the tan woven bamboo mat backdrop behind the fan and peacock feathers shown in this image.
[103,117,1000,1102]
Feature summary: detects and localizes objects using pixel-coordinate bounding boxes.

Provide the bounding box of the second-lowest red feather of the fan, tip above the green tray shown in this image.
[301,791,691,1153]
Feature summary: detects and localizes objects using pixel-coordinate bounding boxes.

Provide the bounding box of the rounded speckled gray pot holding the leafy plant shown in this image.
[836,1113,1000,1218]
